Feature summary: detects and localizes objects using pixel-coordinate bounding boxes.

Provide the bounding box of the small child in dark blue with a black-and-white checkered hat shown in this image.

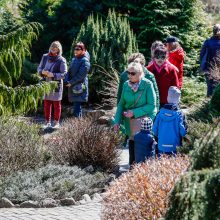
[134,117,154,163]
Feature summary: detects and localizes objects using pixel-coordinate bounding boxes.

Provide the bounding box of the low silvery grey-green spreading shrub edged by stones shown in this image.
[0,165,108,203]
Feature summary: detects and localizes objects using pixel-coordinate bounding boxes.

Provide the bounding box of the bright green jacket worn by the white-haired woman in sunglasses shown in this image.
[114,78,157,136]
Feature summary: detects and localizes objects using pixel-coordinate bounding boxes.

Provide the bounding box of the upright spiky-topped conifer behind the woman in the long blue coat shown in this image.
[73,11,138,101]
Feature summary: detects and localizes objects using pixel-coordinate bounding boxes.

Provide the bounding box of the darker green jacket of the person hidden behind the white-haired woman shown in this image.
[117,67,160,111]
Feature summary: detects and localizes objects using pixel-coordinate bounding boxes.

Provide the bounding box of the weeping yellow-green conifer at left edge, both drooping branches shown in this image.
[0,23,56,114]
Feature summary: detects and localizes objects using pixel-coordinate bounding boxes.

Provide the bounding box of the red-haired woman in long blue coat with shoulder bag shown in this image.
[66,42,90,118]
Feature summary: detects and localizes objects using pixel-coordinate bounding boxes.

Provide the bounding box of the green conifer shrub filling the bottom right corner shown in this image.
[165,169,220,220]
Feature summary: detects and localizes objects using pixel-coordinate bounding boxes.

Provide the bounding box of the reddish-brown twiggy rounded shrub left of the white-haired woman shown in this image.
[46,118,121,172]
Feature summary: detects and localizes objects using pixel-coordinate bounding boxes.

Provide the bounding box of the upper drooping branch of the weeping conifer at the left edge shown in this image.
[0,22,41,86]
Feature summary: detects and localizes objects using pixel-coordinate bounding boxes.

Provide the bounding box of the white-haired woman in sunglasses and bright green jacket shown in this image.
[114,62,157,165]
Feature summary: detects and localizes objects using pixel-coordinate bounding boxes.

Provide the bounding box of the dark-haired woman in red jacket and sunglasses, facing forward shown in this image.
[147,47,179,108]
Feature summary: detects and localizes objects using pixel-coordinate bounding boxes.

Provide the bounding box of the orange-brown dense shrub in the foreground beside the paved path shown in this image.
[103,155,189,220]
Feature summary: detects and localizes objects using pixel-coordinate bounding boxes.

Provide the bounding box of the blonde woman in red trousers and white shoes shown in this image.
[38,41,67,128]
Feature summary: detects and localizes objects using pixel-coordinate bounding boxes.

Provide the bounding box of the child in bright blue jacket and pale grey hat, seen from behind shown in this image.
[153,86,187,154]
